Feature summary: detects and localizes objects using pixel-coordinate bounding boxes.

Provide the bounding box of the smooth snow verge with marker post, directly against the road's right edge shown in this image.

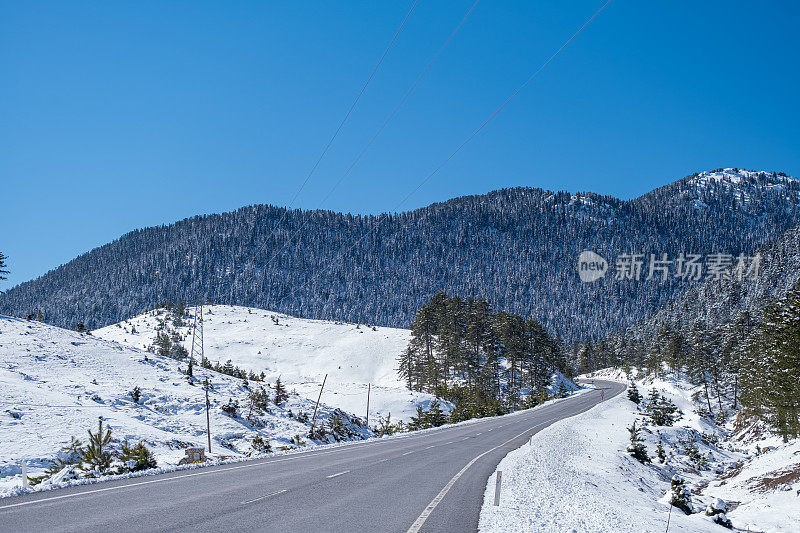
[478,393,724,533]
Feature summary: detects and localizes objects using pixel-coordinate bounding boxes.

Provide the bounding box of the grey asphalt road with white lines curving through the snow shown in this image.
[0,380,624,533]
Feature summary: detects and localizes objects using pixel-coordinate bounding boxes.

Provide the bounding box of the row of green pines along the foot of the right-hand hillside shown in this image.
[578,282,800,440]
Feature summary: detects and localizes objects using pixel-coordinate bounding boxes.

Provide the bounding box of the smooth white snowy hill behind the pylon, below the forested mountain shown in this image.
[93,305,434,424]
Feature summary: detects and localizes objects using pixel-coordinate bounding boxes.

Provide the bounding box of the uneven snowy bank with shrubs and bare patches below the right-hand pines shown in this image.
[564,369,800,532]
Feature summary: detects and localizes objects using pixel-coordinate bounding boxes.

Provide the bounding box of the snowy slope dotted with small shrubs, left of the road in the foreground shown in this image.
[0,316,369,493]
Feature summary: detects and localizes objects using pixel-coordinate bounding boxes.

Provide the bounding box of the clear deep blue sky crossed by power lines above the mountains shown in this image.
[0,0,800,289]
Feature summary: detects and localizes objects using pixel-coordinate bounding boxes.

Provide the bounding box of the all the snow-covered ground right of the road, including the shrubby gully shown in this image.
[479,371,800,533]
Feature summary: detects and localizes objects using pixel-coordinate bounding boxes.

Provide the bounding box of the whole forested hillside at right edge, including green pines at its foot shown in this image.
[578,222,800,440]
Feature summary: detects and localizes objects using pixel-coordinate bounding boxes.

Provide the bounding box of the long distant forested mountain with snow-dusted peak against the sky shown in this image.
[0,169,800,341]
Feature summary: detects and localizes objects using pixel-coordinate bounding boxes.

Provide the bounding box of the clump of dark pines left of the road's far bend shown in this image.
[398,292,573,421]
